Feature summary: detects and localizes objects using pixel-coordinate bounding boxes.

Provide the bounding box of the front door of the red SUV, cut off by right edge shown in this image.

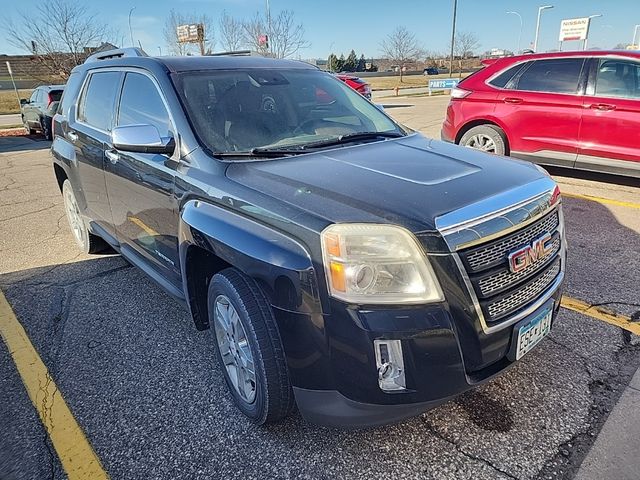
[576,57,640,173]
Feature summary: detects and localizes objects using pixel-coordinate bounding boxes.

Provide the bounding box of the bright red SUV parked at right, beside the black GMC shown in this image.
[442,50,640,177]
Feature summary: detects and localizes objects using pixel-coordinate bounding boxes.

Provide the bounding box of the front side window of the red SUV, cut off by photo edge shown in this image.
[596,58,640,99]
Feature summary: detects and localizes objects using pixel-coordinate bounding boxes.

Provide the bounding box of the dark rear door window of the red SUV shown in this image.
[516,58,584,93]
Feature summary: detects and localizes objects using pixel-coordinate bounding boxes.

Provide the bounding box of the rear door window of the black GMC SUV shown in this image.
[78,72,120,130]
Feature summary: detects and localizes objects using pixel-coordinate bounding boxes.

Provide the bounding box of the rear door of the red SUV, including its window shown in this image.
[495,58,585,166]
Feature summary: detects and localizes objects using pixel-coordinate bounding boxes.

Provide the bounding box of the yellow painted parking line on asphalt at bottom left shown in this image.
[0,291,109,480]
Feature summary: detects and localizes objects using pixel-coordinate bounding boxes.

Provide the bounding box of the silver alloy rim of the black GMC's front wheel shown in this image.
[214,295,256,404]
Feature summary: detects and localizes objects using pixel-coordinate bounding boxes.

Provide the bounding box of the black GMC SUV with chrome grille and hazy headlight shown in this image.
[51,49,565,427]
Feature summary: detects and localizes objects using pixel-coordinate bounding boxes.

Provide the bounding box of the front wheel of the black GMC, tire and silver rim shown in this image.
[208,268,294,425]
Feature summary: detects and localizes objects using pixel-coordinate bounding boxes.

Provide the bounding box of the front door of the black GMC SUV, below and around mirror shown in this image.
[105,71,180,285]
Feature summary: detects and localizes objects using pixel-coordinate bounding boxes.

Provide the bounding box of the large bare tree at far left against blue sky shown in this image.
[3,0,115,79]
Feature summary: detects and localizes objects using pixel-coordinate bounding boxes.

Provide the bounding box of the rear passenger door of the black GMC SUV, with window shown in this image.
[65,70,123,237]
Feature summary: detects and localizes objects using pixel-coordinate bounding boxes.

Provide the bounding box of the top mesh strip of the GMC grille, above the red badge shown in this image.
[464,211,560,272]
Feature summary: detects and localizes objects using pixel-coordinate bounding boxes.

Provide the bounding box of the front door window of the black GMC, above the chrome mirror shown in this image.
[116,73,173,137]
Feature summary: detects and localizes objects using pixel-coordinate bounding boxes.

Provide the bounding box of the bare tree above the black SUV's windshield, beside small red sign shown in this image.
[243,10,311,58]
